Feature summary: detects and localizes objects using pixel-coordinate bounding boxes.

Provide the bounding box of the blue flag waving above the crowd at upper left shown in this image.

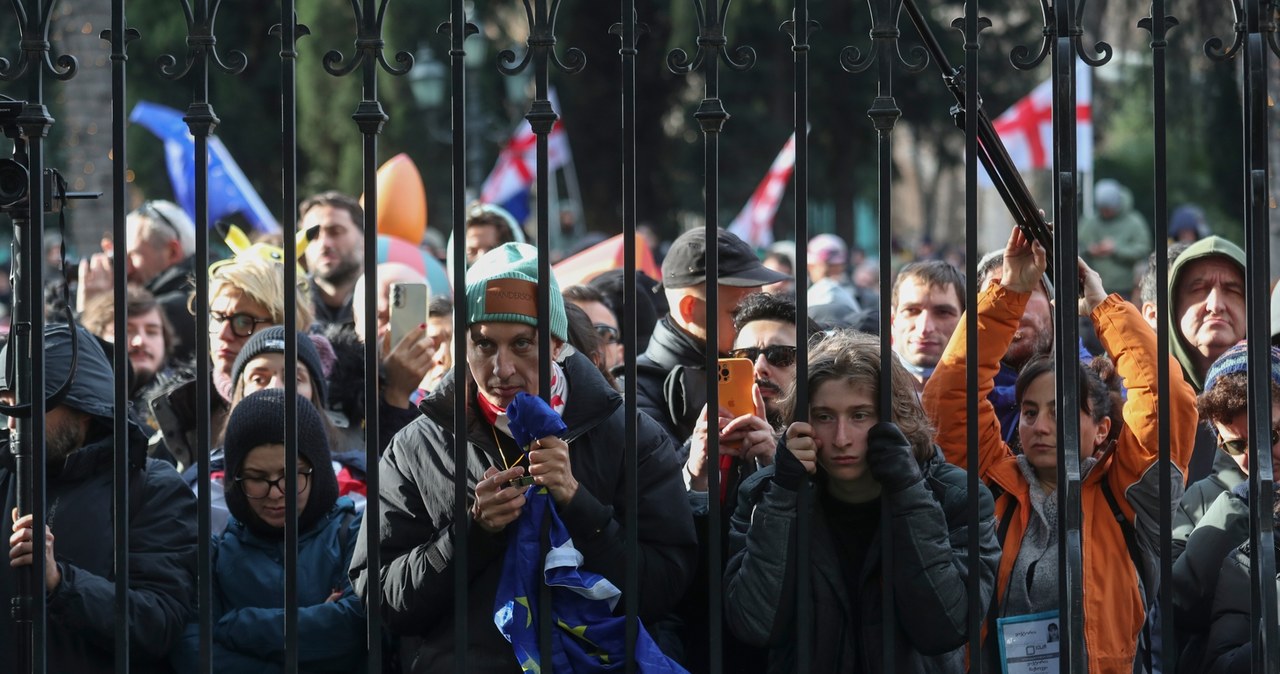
[129,101,280,234]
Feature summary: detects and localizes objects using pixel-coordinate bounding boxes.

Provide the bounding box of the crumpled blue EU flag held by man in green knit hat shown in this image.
[493,394,685,674]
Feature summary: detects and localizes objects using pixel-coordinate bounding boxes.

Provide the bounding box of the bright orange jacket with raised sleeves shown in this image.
[923,283,1197,674]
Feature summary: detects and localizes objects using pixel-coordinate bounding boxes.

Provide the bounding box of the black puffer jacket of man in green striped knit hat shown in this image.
[351,353,698,673]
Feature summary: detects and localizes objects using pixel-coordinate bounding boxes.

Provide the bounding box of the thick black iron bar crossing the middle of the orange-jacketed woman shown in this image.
[1048,0,1088,671]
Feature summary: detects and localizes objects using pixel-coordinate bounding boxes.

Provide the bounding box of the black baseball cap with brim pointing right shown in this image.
[662,228,791,289]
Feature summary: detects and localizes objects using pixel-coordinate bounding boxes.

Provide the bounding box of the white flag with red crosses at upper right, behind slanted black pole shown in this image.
[979,64,1093,185]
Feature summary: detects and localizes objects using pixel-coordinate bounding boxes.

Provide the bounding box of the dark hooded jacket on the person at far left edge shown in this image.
[0,325,196,674]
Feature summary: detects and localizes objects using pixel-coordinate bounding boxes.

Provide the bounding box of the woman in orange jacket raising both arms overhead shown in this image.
[924,229,1197,674]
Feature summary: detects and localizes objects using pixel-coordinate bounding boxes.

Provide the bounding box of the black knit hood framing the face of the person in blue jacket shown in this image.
[223,389,338,538]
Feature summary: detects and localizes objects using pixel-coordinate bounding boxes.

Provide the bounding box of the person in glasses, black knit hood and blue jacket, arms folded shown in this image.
[174,389,365,673]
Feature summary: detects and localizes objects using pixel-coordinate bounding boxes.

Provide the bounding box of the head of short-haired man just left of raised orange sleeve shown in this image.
[890,260,964,391]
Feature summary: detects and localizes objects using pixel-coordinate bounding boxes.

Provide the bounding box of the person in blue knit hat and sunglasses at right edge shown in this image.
[1171,341,1280,671]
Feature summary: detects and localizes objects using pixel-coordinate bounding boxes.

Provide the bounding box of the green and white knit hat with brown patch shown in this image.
[467,243,568,341]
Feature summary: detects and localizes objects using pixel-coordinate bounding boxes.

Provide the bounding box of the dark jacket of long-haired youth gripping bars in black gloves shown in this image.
[724,451,1000,674]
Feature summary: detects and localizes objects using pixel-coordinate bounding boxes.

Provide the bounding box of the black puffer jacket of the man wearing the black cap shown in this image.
[629,316,707,445]
